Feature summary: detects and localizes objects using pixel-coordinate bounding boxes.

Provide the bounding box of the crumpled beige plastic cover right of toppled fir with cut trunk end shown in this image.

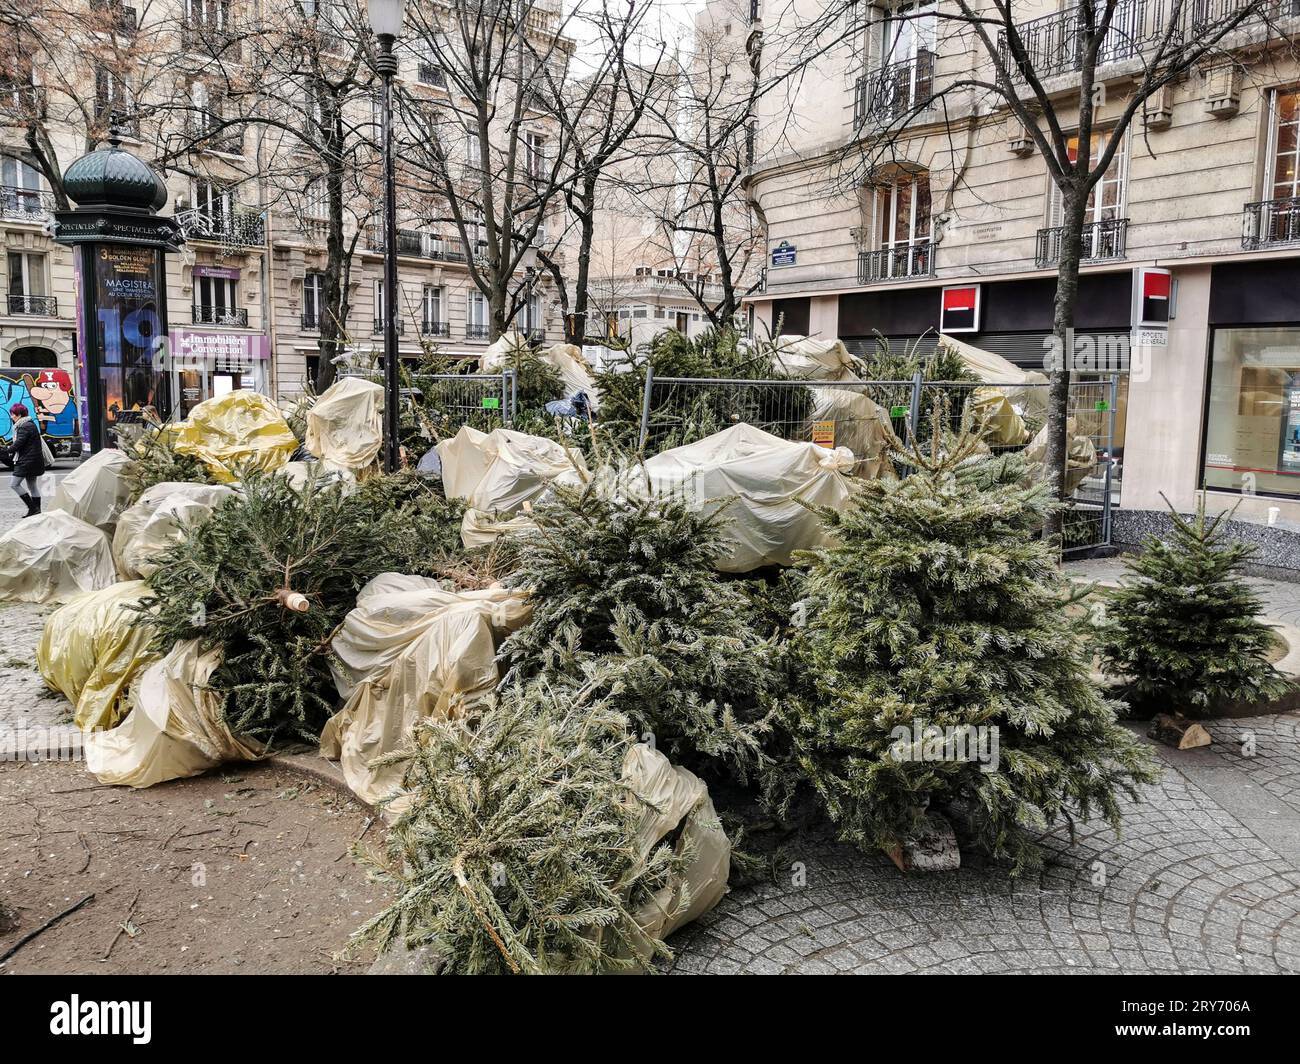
[321,572,530,805]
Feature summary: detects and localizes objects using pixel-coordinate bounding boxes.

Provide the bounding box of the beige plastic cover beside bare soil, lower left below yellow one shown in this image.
[85,639,264,787]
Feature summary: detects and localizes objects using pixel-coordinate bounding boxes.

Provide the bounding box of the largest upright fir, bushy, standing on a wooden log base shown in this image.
[783,410,1152,873]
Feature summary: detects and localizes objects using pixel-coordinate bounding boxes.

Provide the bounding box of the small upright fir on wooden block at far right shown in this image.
[1100,498,1291,715]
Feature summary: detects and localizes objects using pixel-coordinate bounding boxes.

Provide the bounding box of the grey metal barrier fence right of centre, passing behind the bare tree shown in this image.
[640,373,1119,553]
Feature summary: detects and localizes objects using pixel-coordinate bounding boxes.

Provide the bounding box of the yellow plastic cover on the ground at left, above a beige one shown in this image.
[36,580,156,731]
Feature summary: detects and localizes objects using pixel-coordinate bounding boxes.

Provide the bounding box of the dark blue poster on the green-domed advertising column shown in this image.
[95,245,170,432]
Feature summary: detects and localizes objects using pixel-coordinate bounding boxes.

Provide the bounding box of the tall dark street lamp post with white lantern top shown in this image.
[367,0,406,472]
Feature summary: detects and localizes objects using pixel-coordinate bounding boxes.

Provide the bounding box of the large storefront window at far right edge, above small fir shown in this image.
[1205,326,1300,496]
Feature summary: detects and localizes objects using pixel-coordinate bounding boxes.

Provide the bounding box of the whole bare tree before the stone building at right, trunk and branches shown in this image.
[785,0,1287,537]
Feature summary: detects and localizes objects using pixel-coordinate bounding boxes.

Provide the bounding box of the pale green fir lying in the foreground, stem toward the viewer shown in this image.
[356,684,690,974]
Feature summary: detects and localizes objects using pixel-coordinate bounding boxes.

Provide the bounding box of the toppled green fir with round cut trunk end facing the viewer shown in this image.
[140,475,462,743]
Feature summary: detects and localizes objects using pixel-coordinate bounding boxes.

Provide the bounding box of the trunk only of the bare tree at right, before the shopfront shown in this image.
[1043,190,1087,542]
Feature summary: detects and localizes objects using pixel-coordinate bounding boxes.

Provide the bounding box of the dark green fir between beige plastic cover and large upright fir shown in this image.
[502,477,780,779]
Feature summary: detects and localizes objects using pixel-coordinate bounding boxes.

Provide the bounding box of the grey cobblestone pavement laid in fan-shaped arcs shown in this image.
[0,490,1300,974]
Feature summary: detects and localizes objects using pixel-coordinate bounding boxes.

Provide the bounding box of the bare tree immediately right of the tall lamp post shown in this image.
[398,0,572,338]
